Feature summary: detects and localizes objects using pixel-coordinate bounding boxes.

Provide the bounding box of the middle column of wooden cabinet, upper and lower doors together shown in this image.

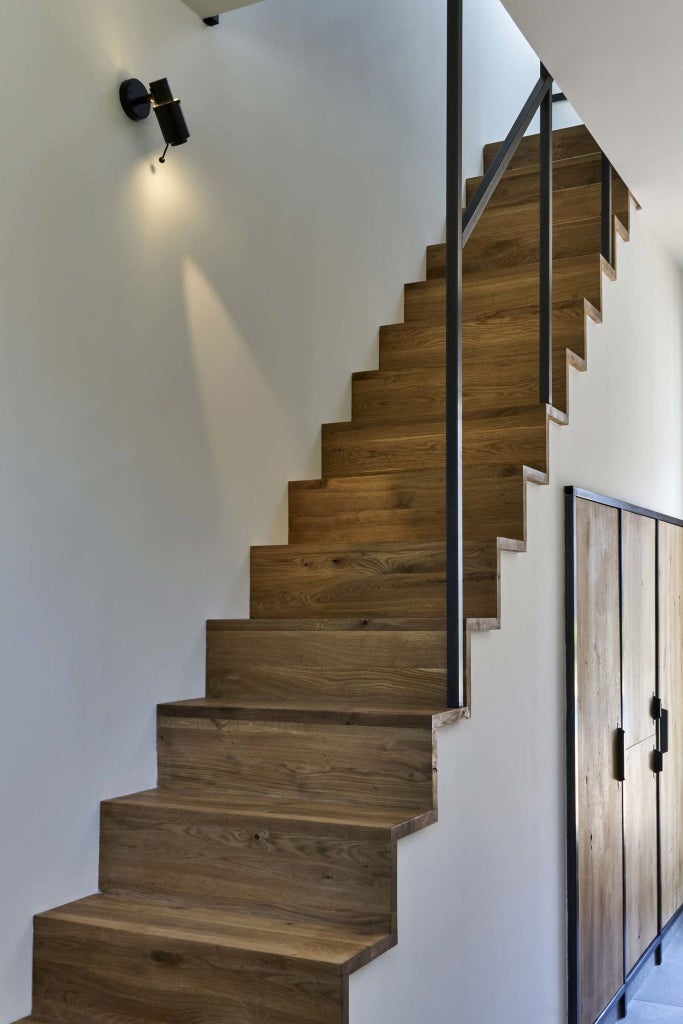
[622,512,657,971]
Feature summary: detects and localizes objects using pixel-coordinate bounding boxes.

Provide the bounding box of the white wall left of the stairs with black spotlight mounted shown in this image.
[0,0,536,1021]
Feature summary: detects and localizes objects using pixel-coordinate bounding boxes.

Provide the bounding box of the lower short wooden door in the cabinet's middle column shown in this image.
[624,734,658,972]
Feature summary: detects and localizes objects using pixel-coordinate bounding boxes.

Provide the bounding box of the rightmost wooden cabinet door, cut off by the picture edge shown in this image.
[659,522,683,925]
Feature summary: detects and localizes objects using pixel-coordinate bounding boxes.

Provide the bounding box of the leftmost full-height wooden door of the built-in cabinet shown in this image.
[575,499,624,1024]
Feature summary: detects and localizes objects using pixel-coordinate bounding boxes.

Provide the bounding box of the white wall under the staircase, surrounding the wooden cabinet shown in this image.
[351,213,683,1024]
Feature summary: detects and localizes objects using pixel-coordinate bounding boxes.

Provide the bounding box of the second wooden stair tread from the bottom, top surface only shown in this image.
[106,788,434,833]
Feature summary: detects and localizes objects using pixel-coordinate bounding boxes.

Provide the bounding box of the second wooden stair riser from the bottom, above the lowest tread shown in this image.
[99,804,394,931]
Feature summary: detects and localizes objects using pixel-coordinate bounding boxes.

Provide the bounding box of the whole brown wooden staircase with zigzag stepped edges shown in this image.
[13,127,630,1024]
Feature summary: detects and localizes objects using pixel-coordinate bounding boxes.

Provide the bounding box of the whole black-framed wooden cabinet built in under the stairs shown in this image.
[566,488,683,1024]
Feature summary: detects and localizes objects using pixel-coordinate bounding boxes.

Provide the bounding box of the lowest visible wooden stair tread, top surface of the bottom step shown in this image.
[37,893,387,971]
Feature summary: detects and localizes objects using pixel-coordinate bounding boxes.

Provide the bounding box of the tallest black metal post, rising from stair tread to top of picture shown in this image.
[445,0,465,708]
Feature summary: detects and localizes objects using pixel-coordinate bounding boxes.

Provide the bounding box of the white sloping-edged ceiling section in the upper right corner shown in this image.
[503,0,683,262]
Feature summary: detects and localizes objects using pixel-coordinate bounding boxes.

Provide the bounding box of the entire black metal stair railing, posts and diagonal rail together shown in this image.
[445,0,613,708]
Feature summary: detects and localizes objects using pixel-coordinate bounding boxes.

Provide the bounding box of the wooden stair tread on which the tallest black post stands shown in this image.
[159,697,467,729]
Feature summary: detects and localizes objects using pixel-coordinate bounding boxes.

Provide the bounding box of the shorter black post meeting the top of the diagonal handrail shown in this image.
[539,65,553,406]
